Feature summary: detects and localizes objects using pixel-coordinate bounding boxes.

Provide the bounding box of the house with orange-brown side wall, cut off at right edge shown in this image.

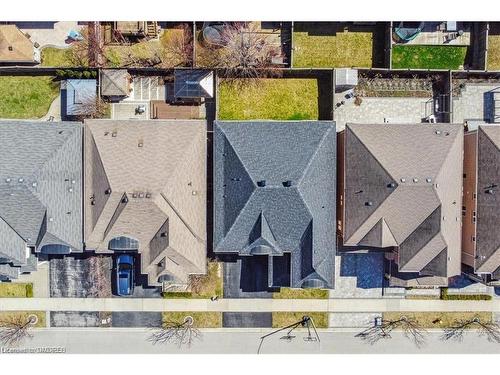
[462,125,500,285]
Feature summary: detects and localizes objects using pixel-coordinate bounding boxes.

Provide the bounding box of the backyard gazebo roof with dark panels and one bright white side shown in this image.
[174,69,214,98]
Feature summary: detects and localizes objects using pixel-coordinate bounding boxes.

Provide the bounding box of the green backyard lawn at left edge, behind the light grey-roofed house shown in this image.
[0,76,59,119]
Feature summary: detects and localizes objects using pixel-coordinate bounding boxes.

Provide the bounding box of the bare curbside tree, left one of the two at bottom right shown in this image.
[356,316,426,348]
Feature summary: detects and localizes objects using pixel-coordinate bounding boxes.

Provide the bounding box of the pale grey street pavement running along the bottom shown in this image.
[6,328,500,354]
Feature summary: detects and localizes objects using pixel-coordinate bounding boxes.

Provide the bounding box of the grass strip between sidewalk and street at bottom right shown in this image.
[382,312,492,328]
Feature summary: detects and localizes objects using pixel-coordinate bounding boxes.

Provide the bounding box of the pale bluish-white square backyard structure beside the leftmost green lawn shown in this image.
[61,79,97,118]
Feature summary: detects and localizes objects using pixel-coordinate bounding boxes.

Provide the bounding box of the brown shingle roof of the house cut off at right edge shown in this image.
[475,125,500,273]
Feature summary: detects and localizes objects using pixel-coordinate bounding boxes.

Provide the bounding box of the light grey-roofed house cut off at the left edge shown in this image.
[0,121,83,280]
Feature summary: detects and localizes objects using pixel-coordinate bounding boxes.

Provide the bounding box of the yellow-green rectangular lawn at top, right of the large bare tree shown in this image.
[293,23,373,68]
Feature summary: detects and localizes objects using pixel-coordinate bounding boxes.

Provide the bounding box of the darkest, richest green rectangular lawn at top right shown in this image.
[392,45,467,69]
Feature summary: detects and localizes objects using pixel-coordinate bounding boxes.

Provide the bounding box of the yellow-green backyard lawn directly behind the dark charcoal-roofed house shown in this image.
[219,78,318,120]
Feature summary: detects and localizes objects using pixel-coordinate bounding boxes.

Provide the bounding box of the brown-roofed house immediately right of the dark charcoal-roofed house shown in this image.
[338,124,463,286]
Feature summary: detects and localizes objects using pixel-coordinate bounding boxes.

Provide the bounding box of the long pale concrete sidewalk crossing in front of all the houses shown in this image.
[0,298,500,313]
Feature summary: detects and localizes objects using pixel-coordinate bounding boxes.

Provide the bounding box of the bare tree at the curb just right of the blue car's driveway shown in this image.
[148,316,201,348]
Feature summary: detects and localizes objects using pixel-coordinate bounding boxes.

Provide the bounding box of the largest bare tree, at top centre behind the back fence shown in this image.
[200,22,282,84]
